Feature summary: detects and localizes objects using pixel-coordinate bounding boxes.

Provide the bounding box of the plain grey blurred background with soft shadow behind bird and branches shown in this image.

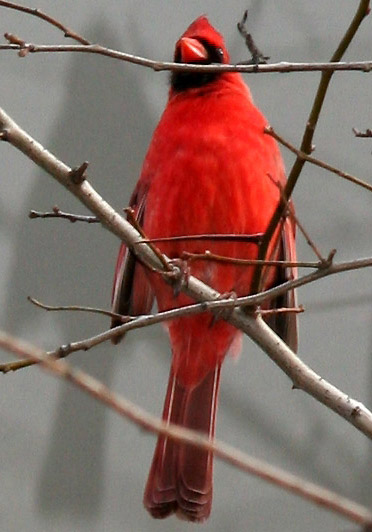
[0,0,372,532]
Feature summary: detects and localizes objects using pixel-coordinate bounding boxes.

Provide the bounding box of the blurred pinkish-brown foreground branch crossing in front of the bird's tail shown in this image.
[0,332,372,526]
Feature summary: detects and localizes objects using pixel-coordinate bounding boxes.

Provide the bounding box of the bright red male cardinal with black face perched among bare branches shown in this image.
[112,16,297,521]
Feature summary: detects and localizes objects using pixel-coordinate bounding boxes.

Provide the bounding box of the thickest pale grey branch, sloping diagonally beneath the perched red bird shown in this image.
[0,104,372,439]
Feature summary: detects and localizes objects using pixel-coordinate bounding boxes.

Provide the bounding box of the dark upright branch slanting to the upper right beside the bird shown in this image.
[252,0,370,292]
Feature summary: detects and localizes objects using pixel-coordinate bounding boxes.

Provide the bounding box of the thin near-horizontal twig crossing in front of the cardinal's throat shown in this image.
[0,43,372,74]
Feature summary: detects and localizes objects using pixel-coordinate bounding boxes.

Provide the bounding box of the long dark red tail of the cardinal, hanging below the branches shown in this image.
[144,365,221,521]
